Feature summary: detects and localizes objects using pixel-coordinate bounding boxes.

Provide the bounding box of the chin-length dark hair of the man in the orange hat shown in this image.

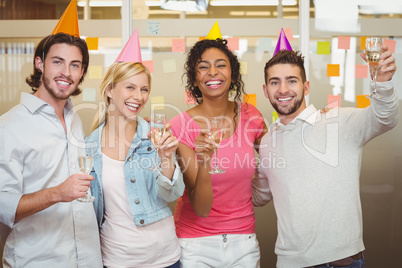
[25,33,89,96]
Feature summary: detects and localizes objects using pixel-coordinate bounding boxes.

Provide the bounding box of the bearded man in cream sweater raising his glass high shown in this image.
[253,48,398,268]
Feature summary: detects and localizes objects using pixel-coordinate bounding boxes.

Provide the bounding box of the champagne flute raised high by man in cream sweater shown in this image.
[366,36,382,99]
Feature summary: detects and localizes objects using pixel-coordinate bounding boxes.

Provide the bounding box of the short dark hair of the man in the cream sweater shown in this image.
[264,50,307,84]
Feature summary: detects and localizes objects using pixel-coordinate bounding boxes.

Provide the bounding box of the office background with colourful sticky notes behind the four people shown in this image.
[0,0,402,268]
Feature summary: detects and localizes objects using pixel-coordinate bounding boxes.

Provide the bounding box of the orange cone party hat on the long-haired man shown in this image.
[52,0,80,37]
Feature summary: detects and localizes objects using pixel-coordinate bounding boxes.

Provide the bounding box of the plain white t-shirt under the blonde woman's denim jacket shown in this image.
[101,154,181,268]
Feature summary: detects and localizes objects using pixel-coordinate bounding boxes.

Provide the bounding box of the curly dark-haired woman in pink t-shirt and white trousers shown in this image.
[170,39,266,268]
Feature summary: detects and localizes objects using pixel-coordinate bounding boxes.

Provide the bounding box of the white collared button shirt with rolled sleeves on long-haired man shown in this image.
[0,93,102,268]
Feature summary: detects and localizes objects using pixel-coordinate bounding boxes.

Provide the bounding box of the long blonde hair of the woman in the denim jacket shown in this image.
[92,62,151,131]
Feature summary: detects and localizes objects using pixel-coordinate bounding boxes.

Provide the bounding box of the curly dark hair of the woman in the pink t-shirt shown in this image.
[183,38,245,105]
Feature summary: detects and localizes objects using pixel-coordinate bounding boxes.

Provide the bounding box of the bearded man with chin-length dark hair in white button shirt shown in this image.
[0,33,102,267]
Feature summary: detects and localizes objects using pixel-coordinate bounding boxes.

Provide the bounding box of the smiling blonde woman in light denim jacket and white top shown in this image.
[86,62,184,267]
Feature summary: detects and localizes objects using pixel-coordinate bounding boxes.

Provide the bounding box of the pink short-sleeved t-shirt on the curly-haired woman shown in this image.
[170,103,264,238]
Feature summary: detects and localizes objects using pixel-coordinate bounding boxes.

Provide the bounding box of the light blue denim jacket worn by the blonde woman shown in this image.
[85,117,184,227]
